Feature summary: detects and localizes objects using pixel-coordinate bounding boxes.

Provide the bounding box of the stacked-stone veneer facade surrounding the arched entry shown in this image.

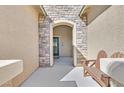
[39,5,87,66]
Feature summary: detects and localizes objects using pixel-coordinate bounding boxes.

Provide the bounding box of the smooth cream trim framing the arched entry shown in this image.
[50,20,77,66]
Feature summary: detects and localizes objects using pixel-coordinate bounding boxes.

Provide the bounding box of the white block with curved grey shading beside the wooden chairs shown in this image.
[100,58,124,86]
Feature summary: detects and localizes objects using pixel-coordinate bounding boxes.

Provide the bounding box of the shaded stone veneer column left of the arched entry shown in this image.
[39,16,52,67]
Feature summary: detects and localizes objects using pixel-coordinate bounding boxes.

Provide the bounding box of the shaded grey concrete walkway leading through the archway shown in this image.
[21,57,77,87]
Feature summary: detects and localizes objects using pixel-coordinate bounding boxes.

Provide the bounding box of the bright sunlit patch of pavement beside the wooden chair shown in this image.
[61,67,100,87]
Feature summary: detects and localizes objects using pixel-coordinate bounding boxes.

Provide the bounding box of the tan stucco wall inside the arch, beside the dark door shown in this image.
[53,25,73,57]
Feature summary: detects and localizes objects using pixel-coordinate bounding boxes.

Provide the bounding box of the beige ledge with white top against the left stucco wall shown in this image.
[0,60,23,86]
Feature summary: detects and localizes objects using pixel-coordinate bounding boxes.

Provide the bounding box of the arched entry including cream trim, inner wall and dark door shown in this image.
[50,20,77,66]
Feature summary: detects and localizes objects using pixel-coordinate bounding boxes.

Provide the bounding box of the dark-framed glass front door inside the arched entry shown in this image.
[53,37,59,57]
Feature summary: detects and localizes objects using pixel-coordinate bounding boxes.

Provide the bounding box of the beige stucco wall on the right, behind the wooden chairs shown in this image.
[87,6,124,58]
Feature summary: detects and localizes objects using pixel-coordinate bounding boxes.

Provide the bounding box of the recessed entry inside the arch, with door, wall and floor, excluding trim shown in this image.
[53,25,73,65]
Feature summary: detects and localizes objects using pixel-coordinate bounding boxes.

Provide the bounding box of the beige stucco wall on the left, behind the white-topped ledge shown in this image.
[0,6,39,86]
